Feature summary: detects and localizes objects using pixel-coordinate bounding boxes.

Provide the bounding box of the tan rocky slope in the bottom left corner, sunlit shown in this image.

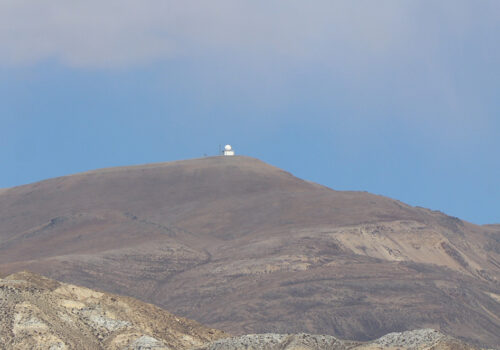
[0,272,226,350]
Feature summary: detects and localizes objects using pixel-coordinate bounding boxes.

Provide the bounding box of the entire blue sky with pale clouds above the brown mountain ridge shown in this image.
[0,0,500,224]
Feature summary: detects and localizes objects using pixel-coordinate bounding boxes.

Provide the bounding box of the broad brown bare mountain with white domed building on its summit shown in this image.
[0,156,500,346]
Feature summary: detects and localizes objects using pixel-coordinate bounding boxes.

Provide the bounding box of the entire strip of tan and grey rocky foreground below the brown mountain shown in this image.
[0,272,486,350]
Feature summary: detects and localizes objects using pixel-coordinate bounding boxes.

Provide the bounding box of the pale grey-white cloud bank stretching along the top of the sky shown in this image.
[0,0,430,67]
